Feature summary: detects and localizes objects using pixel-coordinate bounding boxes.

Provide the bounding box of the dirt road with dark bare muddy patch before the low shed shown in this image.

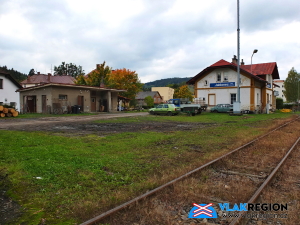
[0,112,212,136]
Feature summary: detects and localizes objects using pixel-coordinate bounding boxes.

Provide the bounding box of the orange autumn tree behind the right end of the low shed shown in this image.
[107,68,143,99]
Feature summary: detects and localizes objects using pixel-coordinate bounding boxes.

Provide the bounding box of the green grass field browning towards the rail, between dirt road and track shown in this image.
[0,113,295,224]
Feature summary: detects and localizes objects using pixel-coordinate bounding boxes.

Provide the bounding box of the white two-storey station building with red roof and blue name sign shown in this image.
[187,56,279,112]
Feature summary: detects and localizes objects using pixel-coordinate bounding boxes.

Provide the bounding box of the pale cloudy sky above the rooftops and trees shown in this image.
[0,0,300,83]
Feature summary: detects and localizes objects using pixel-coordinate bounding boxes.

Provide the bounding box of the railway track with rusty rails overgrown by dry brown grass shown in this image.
[81,118,300,225]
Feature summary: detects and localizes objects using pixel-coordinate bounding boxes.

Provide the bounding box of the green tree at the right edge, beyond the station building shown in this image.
[283,67,300,102]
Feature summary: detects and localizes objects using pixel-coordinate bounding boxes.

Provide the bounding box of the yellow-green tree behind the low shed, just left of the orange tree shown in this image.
[82,61,111,87]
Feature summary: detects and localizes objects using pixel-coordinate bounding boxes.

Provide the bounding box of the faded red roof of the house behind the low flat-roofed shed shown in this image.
[21,74,75,84]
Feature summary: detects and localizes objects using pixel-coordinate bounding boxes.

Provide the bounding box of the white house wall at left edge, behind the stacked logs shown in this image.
[0,74,20,110]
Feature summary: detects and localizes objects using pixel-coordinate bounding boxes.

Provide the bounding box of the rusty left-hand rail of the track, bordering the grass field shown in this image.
[80,117,299,225]
